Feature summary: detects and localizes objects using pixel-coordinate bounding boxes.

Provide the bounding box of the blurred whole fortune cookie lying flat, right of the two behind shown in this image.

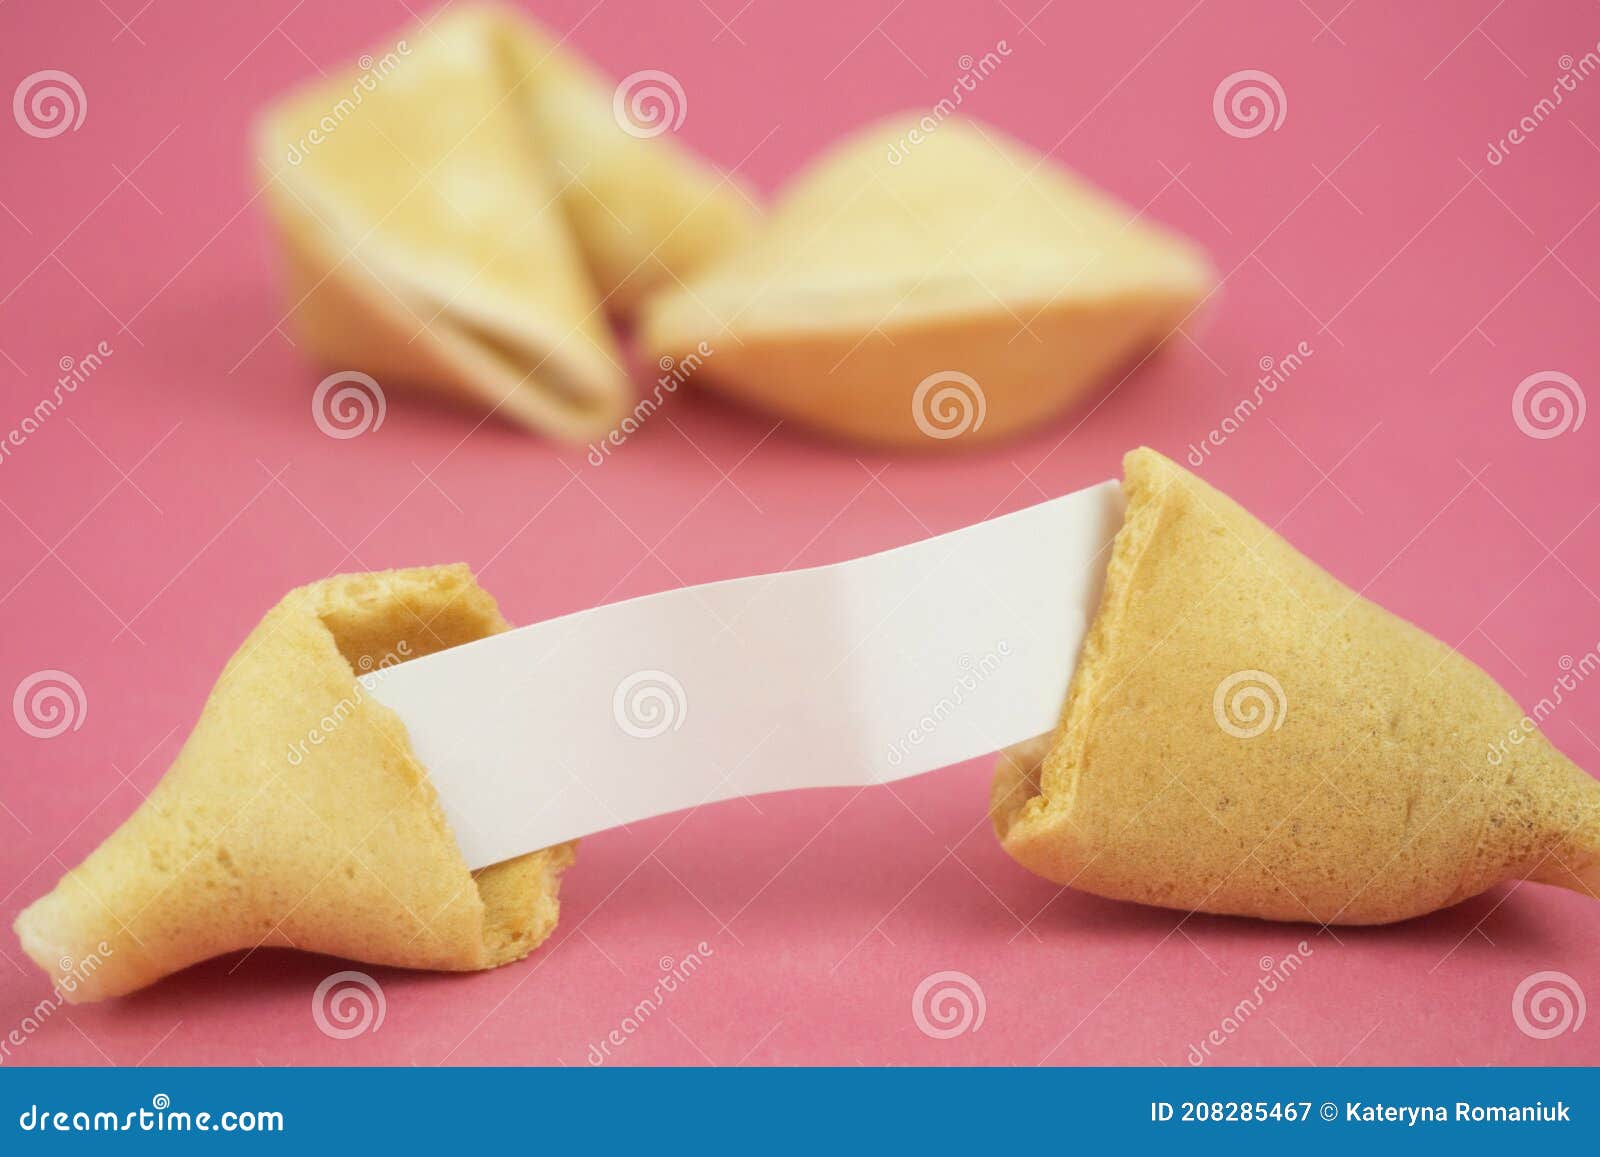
[642,120,1216,446]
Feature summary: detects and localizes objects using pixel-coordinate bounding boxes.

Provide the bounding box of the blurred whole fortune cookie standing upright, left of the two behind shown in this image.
[256,6,755,440]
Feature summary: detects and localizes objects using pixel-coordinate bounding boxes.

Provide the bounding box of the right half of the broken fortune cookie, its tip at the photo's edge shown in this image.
[990,450,1600,923]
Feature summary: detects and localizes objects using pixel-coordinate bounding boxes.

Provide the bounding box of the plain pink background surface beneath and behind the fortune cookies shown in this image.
[0,0,1600,1066]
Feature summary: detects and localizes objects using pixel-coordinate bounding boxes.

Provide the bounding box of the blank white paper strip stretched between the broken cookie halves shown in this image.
[370,482,1123,867]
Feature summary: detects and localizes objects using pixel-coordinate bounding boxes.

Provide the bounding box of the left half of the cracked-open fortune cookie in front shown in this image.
[16,566,573,1002]
